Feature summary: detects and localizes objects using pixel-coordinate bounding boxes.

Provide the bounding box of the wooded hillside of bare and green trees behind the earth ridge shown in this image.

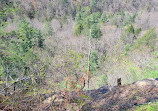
[0,0,158,111]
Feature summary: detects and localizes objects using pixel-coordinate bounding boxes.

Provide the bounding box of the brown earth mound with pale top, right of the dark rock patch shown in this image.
[82,79,158,111]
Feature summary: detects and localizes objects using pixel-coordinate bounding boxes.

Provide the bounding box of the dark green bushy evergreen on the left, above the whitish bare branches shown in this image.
[17,19,44,52]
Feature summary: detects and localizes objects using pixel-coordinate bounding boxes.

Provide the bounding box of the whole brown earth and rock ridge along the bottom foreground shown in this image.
[40,79,158,111]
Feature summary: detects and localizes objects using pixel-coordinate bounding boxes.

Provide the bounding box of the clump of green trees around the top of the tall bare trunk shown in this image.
[74,7,101,38]
